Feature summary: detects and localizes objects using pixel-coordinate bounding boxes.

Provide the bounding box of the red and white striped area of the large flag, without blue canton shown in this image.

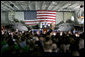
[24,10,56,25]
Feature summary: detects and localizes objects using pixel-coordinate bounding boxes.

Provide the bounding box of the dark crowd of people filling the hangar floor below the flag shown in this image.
[1,25,84,56]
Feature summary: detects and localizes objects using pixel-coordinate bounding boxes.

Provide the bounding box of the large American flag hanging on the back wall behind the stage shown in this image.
[24,10,56,25]
